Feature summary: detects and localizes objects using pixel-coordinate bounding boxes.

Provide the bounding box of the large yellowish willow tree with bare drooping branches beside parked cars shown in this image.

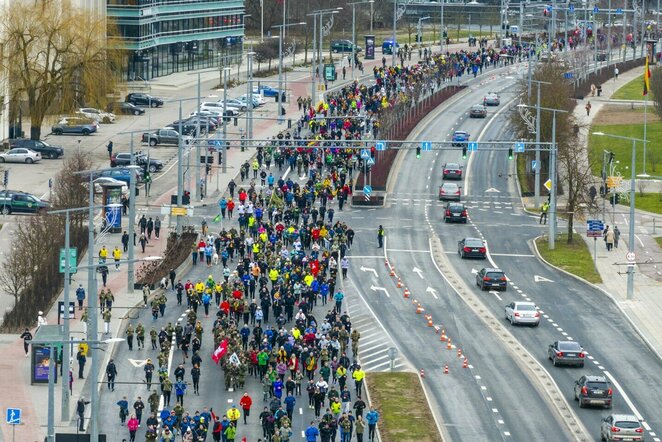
[0,0,119,139]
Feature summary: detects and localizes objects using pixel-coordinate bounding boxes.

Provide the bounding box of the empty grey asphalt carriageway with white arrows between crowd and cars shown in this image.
[345,67,568,440]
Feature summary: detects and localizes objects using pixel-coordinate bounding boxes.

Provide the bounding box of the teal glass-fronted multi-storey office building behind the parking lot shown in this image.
[107,0,244,81]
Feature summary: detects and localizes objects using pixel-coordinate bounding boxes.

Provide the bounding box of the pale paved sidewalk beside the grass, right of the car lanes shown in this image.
[536,63,662,357]
